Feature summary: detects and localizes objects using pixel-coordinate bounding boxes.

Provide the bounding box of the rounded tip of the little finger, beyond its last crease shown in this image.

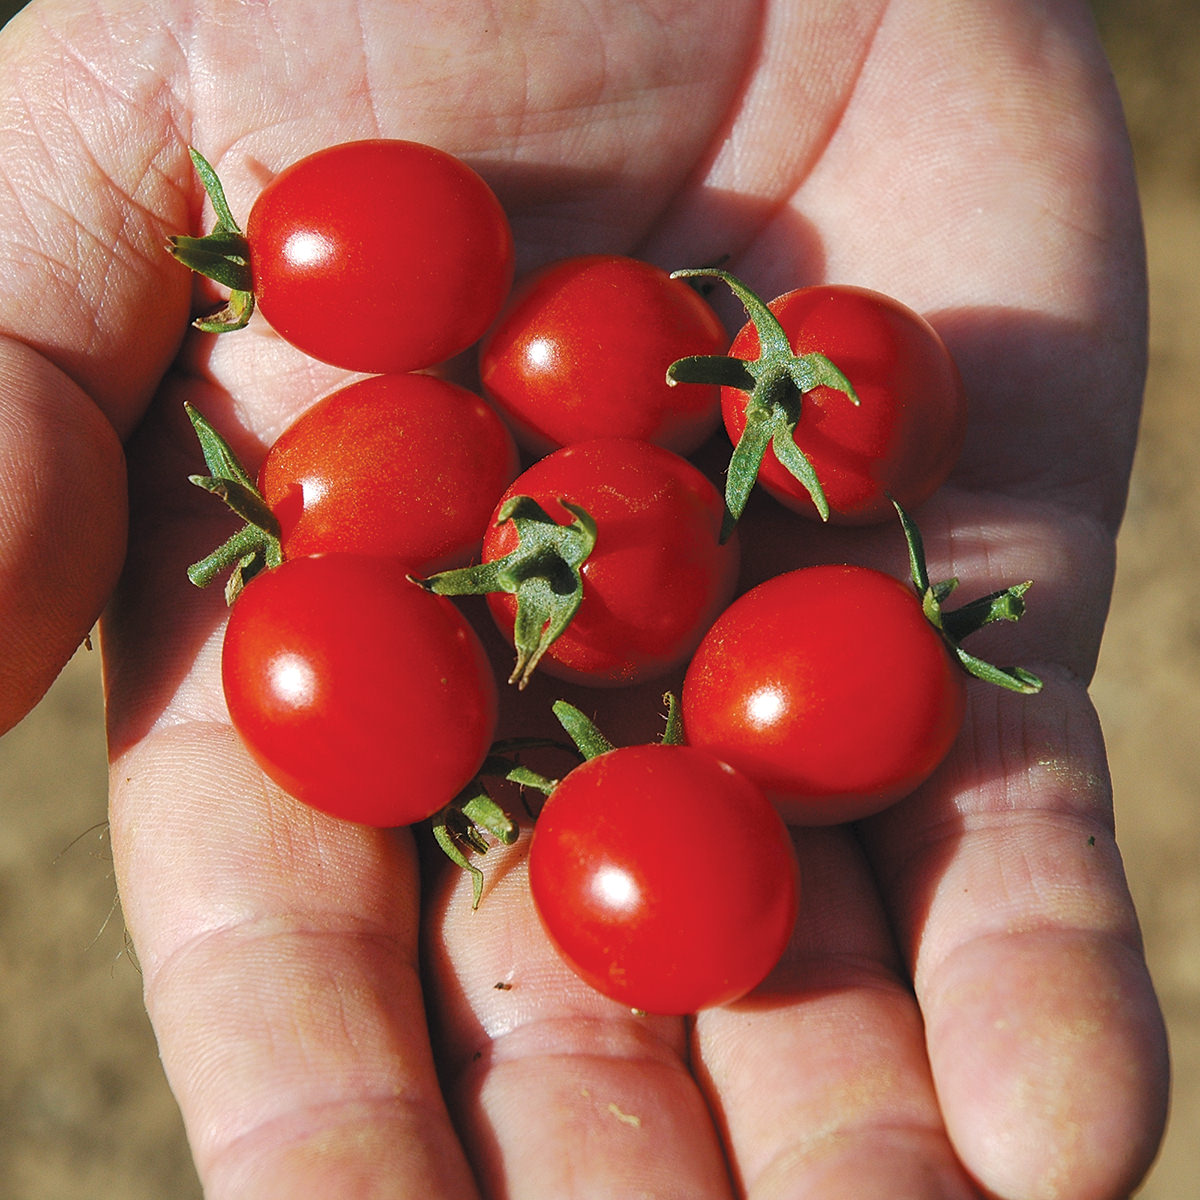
[929,931,1169,1200]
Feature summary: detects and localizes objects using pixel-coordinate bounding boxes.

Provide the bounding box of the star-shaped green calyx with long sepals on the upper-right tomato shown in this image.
[667,266,858,541]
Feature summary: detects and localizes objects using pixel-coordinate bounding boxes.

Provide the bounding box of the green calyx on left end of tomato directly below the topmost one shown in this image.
[184,404,283,604]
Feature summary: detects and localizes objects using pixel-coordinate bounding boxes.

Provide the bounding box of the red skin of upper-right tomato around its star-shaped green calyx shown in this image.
[721,284,966,524]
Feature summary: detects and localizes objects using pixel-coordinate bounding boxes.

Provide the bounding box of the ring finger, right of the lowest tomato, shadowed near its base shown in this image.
[695,827,976,1200]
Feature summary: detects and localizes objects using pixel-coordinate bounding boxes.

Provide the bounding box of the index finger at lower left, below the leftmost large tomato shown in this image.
[112,720,474,1200]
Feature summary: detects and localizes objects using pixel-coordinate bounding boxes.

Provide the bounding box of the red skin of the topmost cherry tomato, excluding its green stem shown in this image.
[246,138,512,374]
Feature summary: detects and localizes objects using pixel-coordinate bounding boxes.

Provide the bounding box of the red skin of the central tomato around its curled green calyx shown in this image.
[484,438,739,686]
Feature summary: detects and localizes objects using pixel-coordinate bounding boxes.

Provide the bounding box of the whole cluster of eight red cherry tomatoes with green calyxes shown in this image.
[172,140,1038,1013]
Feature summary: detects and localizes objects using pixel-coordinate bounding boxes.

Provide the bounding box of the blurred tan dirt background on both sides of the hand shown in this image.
[0,0,1200,1200]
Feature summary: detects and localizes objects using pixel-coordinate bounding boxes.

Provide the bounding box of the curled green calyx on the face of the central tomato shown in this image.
[415,496,596,688]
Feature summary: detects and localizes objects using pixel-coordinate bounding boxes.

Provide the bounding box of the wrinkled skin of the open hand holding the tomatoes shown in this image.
[0,0,1166,1200]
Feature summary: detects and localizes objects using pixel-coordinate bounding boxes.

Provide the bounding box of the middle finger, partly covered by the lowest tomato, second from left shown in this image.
[417,839,730,1200]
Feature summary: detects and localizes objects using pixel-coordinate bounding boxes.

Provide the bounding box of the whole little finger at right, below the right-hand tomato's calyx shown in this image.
[866,672,1168,1200]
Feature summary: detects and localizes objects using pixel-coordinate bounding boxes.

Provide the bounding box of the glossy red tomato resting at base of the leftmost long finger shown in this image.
[221,554,497,826]
